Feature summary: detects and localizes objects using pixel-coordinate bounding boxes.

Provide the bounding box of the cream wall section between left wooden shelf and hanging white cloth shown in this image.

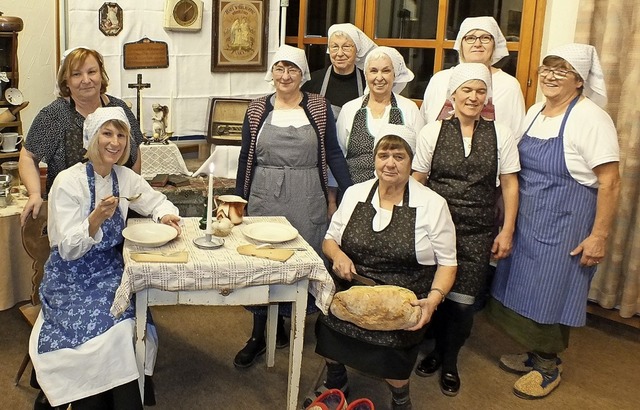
[0,0,57,135]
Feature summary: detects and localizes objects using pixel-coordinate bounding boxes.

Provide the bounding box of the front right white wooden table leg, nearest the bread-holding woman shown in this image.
[287,278,309,410]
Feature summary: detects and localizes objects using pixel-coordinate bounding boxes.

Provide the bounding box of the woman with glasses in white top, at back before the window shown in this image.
[420,16,525,133]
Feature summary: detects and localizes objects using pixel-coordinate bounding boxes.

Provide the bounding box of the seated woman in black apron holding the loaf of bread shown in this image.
[305,124,456,409]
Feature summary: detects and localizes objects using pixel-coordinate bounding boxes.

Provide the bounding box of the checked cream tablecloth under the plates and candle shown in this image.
[111,217,335,315]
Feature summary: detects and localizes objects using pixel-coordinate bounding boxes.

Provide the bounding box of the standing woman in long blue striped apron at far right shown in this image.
[489,44,620,399]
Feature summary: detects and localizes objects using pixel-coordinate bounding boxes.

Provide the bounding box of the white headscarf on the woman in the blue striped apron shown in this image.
[546,43,607,108]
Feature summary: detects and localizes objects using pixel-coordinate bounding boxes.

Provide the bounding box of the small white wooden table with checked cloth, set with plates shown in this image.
[111,217,335,410]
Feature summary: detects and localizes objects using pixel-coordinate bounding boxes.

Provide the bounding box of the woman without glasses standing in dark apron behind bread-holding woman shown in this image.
[413,63,520,396]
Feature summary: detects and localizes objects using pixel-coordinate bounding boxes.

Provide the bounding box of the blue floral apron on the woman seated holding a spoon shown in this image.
[38,162,134,353]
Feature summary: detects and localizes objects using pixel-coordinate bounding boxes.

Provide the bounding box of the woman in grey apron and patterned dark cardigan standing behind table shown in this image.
[233,45,351,367]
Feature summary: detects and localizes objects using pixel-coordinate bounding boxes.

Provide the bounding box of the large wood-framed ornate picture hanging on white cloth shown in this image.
[211,0,269,72]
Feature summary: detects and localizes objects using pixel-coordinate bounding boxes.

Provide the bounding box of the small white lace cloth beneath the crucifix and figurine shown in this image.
[140,142,191,179]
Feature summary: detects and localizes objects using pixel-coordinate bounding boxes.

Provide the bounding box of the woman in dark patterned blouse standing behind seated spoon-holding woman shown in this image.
[19,47,142,224]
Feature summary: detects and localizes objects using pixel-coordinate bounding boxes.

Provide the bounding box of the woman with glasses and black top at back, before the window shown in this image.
[302,23,377,118]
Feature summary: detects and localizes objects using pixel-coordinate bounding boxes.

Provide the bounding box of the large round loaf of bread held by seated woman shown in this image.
[330,285,422,330]
